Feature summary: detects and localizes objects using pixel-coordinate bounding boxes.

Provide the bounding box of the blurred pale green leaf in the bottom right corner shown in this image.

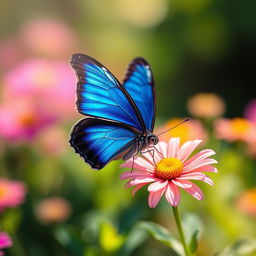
[215,238,256,256]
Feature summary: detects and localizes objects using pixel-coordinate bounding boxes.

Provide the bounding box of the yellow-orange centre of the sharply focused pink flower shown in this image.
[155,157,183,180]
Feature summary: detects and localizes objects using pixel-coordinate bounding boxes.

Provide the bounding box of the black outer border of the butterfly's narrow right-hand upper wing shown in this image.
[123,57,156,132]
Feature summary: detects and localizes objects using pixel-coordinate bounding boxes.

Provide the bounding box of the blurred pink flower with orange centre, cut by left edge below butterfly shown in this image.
[0,178,26,212]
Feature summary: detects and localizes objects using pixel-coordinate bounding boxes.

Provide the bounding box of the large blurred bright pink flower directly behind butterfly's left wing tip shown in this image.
[3,59,76,120]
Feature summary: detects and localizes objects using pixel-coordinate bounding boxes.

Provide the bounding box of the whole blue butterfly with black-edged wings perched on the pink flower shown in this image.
[70,54,158,169]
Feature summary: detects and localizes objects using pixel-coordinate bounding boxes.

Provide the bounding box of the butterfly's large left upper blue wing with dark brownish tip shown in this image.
[71,54,145,132]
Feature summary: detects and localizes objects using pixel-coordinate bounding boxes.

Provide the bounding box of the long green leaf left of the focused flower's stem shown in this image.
[138,221,184,255]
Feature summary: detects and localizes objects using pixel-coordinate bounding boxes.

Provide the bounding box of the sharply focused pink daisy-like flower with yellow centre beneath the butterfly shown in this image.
[121,138,217,208]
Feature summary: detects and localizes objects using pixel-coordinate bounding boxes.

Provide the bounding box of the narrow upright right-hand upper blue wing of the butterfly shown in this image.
[123,58,156,131]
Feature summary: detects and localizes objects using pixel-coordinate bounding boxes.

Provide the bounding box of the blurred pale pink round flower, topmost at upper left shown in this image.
[19,19,76,57]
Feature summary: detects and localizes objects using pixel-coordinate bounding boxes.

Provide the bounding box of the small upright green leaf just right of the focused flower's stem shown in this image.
[182,214,204,254]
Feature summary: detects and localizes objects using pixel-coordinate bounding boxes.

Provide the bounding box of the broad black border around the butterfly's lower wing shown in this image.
[69,117,138,170]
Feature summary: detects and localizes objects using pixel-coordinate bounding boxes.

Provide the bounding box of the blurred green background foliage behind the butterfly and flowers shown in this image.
[0,0,256,256]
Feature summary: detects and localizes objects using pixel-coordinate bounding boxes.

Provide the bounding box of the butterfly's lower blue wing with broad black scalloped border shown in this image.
[70,117,138,169]
